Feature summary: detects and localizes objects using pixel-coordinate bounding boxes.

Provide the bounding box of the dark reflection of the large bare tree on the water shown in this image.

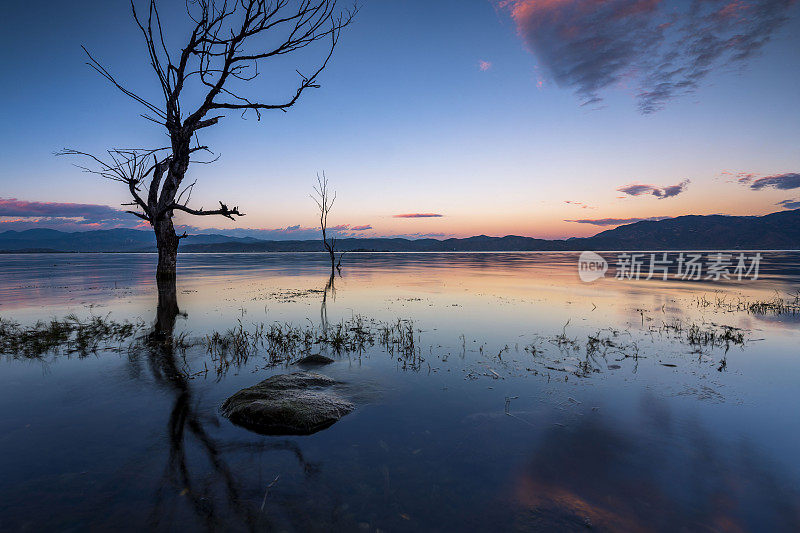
[146,279,318,531]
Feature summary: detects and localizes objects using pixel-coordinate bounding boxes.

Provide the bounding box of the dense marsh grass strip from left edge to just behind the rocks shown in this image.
[0,314,424,376]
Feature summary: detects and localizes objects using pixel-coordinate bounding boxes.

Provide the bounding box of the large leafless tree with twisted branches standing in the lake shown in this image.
[61,0,357,278]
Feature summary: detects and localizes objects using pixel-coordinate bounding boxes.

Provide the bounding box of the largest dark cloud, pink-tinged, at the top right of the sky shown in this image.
[498,0,795,114]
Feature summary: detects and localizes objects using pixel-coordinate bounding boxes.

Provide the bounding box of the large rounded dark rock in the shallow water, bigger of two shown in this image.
[221,372,354,435]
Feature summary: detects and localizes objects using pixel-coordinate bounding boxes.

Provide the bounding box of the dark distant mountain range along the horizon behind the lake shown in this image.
[0,209,800,253]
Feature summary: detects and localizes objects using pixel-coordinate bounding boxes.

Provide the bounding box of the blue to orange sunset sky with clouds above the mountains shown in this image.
[0,0,800,238]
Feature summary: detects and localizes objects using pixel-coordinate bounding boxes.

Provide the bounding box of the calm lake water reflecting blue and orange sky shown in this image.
[0,253,800,531]
